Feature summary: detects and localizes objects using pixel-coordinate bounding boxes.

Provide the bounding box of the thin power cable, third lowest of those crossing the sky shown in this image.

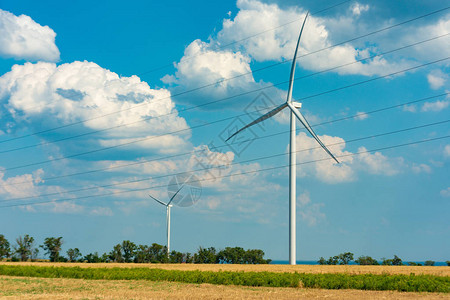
[0,92,450,187]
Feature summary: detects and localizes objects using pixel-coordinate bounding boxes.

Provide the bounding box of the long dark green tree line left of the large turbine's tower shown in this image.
[0,234,271,264]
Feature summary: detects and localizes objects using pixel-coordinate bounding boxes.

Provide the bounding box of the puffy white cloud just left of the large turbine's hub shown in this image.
[161,40,282,109]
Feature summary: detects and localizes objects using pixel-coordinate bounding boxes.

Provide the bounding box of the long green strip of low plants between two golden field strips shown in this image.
[0,265,450,293]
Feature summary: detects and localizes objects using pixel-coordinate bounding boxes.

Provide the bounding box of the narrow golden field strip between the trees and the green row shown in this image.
[0,262,450,276]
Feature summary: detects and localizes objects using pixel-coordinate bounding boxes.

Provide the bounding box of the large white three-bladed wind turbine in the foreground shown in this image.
[227,12,339,265]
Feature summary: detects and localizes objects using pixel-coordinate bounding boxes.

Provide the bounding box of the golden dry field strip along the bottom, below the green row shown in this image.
[0,276,450,299]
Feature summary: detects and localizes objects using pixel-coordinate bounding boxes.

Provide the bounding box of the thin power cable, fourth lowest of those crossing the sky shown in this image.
[3,57,450,171]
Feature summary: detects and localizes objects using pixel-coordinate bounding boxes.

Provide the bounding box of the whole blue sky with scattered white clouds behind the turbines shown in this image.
[0,0,450,260]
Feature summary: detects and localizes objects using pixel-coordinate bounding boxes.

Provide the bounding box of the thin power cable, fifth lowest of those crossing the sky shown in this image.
[0,33,450,154]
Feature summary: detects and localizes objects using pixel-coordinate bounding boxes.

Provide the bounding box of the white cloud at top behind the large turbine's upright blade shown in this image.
[217,0,408,75]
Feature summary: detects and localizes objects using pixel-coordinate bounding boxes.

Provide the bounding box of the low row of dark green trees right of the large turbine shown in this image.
[317,252,450,266]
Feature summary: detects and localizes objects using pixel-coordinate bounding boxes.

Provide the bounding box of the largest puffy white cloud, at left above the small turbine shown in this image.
[0,61,190,152]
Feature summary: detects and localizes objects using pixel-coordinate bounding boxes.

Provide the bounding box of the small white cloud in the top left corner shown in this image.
[0,9,59,61]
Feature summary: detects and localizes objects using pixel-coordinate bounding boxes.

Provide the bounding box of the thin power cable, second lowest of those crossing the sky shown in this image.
[0,119,450,202]
